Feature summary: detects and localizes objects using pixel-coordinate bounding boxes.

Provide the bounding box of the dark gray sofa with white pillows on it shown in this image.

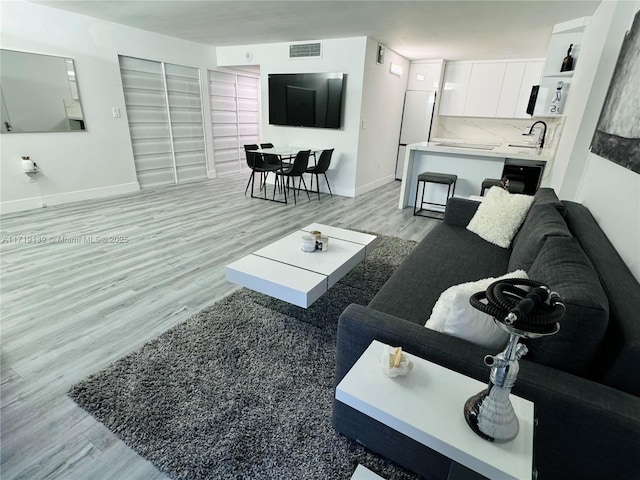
[333,189,640,480]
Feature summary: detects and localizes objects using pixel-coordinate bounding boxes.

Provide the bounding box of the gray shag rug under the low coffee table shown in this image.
[69,236,417,480]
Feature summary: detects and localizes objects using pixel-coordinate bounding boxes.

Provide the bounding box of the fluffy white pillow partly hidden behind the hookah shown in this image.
[425,270,528,350]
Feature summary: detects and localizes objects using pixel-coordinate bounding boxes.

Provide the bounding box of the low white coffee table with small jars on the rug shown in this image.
[225,223,378,308]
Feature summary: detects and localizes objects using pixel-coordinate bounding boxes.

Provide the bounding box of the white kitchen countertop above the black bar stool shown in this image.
[407,139,554,162]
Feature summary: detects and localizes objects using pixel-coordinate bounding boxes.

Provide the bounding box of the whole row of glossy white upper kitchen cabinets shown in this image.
[439,59,544,118]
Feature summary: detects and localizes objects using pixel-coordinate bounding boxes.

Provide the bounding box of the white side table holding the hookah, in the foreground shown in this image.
[336,341,534,479]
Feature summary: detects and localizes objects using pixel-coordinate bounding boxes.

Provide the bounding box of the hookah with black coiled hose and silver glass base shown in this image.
[464,278,566,443]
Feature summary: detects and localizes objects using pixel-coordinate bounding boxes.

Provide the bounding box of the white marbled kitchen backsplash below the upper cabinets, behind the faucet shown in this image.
[431,116,564,151]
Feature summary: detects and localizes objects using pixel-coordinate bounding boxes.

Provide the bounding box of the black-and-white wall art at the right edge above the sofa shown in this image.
[591,11,640,173]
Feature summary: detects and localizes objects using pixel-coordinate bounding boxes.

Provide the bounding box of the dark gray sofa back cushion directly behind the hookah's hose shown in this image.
[526,237,609,376]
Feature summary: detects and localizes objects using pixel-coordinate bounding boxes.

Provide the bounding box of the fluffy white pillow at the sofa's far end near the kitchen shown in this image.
[467,187,533,248]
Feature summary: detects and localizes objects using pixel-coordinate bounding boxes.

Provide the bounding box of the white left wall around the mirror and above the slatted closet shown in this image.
[0,0,215,213]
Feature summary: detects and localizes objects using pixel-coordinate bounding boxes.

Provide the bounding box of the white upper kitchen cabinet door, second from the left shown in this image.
[464,62,507,117]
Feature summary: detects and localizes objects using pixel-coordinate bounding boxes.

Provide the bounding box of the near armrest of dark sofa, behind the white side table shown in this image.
[334,305,640,478]
